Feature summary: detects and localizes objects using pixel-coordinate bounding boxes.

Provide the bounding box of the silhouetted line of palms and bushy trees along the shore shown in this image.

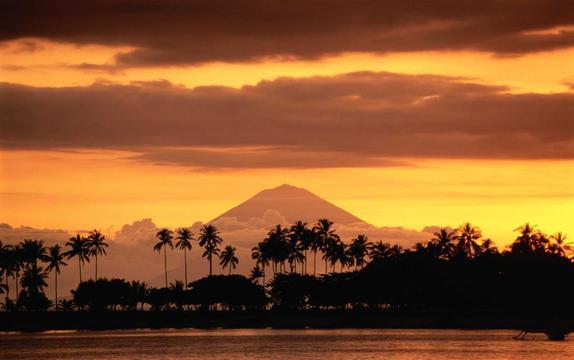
[0,219,574,311]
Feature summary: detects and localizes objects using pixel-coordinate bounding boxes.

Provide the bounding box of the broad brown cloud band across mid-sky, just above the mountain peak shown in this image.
[0,72,574,168]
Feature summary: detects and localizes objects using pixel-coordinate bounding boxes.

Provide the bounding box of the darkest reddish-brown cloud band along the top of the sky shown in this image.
[0,0,574,66]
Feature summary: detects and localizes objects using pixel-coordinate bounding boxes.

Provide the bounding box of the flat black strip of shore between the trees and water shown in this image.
[0,310,574,332]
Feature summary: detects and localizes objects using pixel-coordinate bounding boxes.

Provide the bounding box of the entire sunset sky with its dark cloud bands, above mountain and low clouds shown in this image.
[0,0,574,245]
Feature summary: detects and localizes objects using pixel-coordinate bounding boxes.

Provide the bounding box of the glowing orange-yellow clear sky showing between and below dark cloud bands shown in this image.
[0,0,574,248]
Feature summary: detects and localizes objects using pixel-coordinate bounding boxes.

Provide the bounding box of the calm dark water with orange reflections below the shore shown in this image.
[0,330,574,360]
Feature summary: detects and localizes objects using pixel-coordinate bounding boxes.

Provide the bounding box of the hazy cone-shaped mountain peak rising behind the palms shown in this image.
[212,184,365,225]
